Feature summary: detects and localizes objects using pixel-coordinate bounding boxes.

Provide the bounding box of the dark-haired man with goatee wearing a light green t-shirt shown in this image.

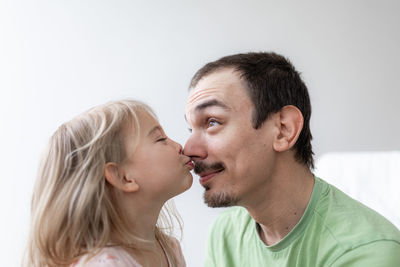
[184,53,400,267]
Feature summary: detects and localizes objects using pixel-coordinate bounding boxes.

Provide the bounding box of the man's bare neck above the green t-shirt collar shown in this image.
[245,163,314,246]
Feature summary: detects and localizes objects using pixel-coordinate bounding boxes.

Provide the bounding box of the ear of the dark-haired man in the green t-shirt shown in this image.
[273,105,304,152]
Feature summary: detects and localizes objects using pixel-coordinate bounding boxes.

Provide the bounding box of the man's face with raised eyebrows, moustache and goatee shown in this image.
[184,68,276,207]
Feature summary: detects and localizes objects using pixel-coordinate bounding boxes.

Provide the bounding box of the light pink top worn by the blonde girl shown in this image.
[71,240,186,267]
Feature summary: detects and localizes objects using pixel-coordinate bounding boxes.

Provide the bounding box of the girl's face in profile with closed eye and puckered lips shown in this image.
[123,111,193,201]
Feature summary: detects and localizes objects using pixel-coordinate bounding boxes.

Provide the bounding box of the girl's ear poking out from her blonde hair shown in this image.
[104,162,139,193]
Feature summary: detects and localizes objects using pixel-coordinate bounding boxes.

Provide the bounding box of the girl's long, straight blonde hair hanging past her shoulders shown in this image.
[25,100,182,267]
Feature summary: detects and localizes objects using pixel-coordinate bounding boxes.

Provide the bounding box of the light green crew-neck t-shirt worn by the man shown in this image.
[205,178,400,267]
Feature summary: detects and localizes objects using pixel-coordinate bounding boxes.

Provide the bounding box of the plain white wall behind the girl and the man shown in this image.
[0,0,400,267]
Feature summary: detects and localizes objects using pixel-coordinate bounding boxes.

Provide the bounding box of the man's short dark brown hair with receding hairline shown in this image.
[190,52,314,169]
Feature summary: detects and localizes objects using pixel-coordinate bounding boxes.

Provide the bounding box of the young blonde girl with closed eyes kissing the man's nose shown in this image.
[26,100,193,267]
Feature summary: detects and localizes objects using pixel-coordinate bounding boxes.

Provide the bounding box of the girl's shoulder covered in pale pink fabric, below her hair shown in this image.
[71,247,141,267]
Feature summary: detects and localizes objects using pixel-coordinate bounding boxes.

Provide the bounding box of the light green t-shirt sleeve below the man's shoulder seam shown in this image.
[331,240,400,267]
